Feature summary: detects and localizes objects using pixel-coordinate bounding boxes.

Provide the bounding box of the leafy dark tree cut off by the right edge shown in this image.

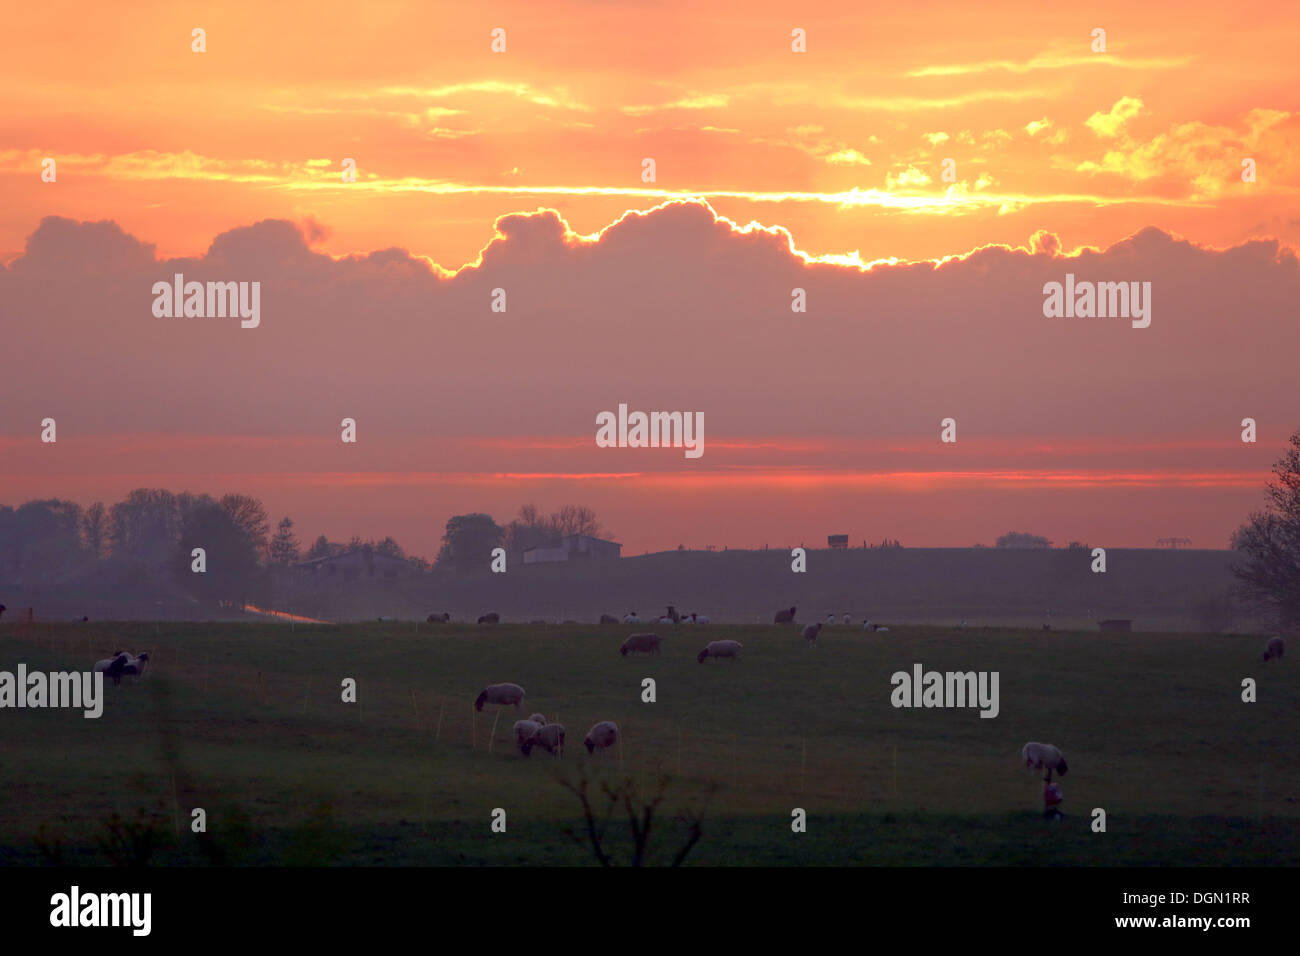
[1232,431,1300,628]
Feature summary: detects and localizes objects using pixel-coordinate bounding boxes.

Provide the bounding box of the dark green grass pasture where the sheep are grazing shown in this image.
[0,622,1300,866]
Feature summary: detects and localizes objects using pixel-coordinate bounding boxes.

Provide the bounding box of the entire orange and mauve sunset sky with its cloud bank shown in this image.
[0,0,1300,555]
